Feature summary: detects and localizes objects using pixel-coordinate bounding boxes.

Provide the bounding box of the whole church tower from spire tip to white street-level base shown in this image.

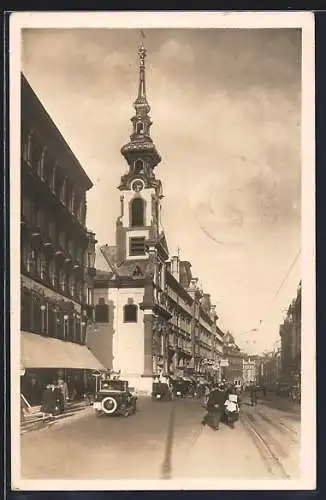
[96,38,170,394]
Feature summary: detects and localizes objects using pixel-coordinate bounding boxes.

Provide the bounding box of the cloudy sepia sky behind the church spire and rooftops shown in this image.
[22,29,301,352]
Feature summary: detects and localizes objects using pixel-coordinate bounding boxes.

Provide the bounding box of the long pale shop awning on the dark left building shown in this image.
[20,332,105,370]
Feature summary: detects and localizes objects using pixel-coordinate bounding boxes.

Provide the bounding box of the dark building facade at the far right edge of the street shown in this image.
[280,283,301,385]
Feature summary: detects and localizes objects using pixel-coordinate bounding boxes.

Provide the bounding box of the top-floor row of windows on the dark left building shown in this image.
[22,132,86,225]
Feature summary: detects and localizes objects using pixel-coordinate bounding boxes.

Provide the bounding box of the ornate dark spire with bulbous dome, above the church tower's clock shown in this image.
[119,36,161,190]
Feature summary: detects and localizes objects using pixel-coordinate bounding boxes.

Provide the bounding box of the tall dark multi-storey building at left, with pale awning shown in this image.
[20,75,100,404]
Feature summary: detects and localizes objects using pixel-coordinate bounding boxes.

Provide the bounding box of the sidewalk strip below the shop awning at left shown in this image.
[20,401,90,434]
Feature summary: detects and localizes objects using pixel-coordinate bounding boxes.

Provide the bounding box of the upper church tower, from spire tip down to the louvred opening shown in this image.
[116,43,163,262]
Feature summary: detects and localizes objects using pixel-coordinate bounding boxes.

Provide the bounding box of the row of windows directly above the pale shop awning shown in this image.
[21,289,86,344]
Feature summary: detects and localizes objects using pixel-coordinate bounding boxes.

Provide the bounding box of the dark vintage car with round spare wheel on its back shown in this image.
[93,379,137,417]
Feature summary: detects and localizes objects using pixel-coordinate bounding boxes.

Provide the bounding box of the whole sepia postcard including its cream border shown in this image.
[10,12,316,491]
